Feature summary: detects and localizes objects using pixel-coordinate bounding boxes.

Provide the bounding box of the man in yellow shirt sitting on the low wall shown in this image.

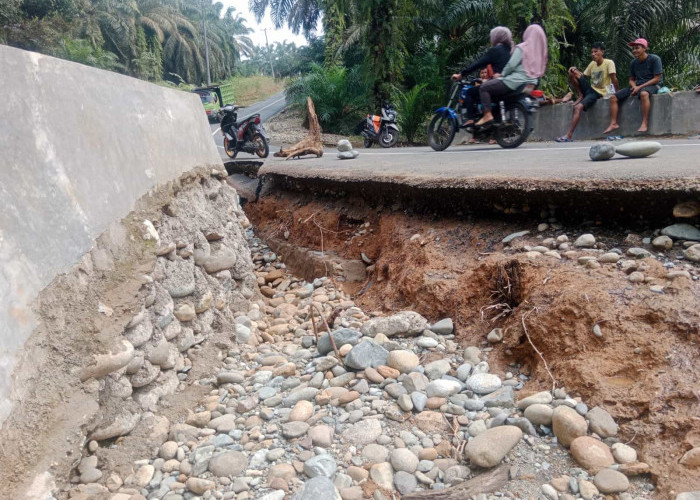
[555,42,620,142]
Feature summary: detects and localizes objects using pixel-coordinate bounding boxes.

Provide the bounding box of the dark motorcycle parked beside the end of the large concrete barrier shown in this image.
[221,104,270,158]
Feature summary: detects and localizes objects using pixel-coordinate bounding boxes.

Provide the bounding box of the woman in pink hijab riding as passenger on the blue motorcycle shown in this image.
[476,24,547,127]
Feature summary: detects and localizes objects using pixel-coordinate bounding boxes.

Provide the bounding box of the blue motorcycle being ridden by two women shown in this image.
[428,79,538,151]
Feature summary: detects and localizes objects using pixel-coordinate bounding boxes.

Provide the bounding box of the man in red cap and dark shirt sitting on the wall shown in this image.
[603,38,663,134]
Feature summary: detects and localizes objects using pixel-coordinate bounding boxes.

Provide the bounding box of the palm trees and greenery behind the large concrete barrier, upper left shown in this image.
[0,0,252,83]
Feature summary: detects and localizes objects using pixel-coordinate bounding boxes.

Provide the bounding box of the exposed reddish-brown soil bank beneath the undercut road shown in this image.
[245,188,700,498]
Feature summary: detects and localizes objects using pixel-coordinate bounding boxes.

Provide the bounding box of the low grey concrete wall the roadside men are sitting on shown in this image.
[530,92,700,141]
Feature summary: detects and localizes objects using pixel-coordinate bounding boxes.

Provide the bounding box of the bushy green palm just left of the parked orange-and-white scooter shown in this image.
[287,64,369,133]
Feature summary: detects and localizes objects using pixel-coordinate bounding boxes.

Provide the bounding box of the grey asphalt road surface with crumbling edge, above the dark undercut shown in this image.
[259,138,700,192]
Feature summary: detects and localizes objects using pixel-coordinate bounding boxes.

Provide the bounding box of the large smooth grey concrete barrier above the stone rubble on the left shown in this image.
[0,45,223,423]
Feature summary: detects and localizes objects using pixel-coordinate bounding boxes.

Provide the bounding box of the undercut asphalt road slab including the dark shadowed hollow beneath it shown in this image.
[259,140,700,224]
